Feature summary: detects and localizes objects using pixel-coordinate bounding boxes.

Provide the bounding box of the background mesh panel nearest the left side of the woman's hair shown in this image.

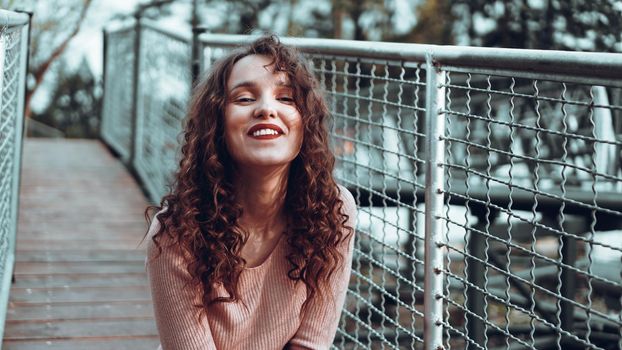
[134,27,191,201]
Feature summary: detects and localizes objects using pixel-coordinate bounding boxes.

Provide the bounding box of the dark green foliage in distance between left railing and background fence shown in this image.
[32,60,102,138]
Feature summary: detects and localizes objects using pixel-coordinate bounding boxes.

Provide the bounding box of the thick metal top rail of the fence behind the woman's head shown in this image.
[199,33,622,87]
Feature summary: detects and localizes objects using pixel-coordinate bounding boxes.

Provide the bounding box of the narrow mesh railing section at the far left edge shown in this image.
[0,9,29,337]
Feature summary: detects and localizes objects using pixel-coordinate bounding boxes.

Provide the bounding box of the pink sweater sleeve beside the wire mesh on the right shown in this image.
[286,186,356,350]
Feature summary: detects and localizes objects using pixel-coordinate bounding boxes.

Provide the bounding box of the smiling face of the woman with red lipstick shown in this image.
[224,55,303,167]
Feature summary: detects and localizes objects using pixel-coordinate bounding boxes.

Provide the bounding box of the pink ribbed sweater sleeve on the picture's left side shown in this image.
[146,218,216,350]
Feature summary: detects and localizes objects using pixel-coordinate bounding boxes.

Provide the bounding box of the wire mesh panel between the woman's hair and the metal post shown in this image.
[309,54,432,349]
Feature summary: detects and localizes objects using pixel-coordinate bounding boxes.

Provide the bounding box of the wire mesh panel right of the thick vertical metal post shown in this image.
[442,72,622,349]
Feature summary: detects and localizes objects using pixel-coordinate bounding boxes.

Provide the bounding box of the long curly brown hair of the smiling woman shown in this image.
[145,35,353,309]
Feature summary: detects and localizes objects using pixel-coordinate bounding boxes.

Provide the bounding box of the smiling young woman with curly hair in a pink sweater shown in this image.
[147,36,356,350]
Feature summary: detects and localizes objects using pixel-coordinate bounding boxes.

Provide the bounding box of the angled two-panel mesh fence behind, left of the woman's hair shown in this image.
[102,19,192,202]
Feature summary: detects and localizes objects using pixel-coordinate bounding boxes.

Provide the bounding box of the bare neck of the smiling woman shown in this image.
[235,166,289,240]
